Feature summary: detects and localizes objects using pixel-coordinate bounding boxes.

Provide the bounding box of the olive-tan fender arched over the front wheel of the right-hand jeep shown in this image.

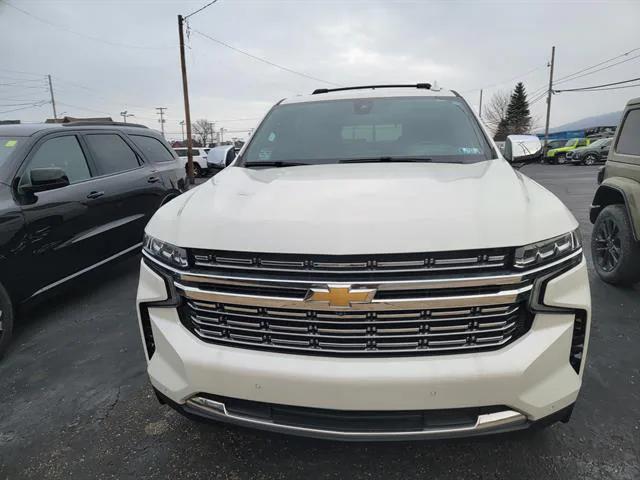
[590,177,640,240]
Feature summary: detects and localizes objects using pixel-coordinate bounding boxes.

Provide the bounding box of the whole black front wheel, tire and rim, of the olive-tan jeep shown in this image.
[591,205,640,285]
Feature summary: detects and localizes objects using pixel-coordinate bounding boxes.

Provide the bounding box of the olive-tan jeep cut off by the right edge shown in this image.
[591,98,640,285]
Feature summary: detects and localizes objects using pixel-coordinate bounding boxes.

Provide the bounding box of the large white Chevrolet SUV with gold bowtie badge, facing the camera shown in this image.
[137,84,591,440]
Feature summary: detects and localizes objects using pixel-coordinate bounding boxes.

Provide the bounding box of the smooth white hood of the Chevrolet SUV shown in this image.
[146,160,578,254]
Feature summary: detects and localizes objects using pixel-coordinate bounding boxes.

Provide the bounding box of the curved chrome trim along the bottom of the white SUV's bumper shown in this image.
[186,395,528,441]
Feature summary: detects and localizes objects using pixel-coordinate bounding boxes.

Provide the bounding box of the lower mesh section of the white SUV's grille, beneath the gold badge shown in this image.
[180,300,529,355]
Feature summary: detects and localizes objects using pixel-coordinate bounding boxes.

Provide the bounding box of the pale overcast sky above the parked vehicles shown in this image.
[0,0,640,138]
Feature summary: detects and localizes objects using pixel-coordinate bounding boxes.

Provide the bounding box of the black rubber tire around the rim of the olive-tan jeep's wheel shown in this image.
[591,205,640,286]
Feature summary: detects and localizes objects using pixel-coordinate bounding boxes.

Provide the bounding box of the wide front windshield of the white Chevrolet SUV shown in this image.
[237,97,495,166]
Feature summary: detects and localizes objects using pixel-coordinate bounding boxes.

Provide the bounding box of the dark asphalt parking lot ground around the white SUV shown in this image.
[0,165,640,480]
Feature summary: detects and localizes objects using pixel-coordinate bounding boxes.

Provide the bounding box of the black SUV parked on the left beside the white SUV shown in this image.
[0,122,185,355]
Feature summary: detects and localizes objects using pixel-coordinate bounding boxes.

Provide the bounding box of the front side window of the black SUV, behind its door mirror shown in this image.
[20,135,91,185]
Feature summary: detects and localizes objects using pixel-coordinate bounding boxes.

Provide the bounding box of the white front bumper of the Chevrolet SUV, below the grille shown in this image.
[138,259,590,440]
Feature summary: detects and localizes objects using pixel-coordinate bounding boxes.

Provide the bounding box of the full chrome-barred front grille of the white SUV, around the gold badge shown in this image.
[145,250,582,356]
